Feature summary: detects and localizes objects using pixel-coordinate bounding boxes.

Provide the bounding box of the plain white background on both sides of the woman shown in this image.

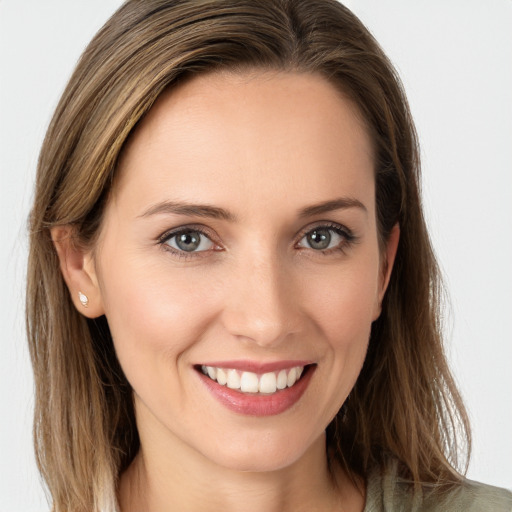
[0,0,512,512]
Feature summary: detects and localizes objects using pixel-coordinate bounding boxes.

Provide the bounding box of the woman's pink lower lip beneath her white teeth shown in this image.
[198,366,316,416]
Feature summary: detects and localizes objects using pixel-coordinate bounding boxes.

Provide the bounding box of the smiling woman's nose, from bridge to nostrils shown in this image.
[222,249,303,347]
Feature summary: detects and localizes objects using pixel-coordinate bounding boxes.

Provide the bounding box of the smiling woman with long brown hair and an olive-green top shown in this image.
[27,0,511,512]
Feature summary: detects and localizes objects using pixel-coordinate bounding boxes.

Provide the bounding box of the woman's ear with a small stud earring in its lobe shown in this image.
[51,225,104,318]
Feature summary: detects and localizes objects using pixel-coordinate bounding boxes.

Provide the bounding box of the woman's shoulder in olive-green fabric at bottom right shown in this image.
[364,464,512,512]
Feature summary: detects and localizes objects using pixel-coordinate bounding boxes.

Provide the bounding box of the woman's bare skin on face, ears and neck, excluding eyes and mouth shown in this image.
[53,71,399,512]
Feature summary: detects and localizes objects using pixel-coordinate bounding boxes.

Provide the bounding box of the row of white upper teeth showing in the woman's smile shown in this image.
[201,365,304,394]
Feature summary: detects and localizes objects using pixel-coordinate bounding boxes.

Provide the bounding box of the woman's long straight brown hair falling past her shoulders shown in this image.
[27,0,470,512]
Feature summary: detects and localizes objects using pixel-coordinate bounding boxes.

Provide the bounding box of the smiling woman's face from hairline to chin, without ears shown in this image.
[87,72,393,470]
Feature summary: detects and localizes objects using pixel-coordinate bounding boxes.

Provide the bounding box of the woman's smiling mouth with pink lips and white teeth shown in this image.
[194,361,317,416]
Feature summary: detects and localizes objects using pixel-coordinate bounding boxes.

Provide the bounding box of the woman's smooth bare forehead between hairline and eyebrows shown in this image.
[116,71,373,218]
